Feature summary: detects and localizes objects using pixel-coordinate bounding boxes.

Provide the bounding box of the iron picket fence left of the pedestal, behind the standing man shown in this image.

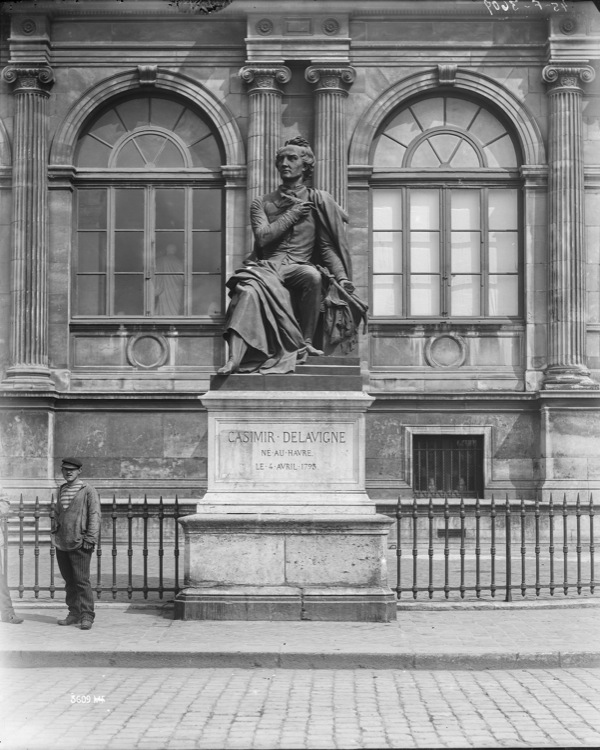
[3,495,185,600]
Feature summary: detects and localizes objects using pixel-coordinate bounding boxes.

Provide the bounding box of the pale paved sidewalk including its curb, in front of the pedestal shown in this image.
[0,600,600,670]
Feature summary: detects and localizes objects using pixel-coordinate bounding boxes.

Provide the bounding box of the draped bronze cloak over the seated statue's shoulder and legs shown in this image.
[224,188,367,373]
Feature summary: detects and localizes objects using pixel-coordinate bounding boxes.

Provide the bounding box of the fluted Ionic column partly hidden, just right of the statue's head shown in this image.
[304,64,356,209]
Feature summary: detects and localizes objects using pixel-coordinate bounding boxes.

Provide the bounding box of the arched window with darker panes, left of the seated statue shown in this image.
[73,96,223,318]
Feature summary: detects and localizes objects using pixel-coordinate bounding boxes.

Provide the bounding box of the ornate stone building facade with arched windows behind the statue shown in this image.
[0,0,600,507]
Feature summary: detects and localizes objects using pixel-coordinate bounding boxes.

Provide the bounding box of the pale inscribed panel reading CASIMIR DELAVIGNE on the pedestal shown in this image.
[216,420,358,487]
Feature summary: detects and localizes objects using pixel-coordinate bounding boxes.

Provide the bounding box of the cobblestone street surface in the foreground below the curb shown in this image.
[0,667,600,750]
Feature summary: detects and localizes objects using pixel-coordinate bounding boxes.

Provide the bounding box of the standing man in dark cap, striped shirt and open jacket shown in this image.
[52,458,100,630]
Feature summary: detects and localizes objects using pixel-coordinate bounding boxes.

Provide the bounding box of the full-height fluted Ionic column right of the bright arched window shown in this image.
[542,64,599,390]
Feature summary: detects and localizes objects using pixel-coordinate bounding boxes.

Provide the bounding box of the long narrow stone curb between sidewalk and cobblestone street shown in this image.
[0,650,600,671]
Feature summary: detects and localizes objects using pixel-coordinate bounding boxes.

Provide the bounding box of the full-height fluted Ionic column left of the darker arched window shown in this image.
[3,65,54,388]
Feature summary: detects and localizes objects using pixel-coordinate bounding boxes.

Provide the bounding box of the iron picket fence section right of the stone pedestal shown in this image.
[395,495,595,602]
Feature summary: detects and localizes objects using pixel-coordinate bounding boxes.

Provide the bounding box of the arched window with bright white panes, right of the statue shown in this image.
[372,94,522,319]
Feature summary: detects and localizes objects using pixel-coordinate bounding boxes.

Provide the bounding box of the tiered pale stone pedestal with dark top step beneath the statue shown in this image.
[175,357,396,622]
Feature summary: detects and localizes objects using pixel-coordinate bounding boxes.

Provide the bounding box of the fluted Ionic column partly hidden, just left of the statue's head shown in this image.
[239,63,292,201]
